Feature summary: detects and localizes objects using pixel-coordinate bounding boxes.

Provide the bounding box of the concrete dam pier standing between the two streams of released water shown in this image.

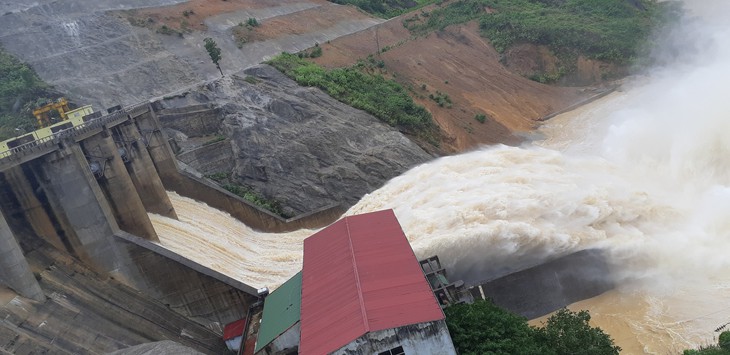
[115,122,177,219]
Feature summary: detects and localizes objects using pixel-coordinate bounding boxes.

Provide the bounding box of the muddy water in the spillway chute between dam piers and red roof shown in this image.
[150,192,314,289]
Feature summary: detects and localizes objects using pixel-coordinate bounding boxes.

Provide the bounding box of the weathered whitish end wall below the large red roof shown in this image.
[333,320,456,355]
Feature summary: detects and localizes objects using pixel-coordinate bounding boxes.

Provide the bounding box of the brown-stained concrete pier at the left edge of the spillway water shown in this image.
[81,130,159,241]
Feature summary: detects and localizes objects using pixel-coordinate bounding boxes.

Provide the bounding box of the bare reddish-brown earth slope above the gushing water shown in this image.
[315,19,583,151]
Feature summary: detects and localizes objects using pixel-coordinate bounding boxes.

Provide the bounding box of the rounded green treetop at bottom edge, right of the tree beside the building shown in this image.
[536,308,621,355]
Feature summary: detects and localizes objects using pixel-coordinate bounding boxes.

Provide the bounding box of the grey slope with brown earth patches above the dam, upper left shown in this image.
[0,0,382,109]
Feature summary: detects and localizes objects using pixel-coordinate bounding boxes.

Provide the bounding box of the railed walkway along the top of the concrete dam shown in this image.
[0,103,150,170]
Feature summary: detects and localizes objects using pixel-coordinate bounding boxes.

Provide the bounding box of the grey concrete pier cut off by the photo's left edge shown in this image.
[0,213,46,301]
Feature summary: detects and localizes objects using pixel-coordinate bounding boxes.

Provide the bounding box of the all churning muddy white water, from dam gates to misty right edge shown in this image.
[153,0,730,354]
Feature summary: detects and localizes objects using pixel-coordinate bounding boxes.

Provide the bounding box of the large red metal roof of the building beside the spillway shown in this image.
[299,210,444,355]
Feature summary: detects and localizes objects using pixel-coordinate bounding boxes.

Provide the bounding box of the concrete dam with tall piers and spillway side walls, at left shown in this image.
[0,104,342,353]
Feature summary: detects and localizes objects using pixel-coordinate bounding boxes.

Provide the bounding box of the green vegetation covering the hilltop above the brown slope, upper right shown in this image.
[404,0,679,75]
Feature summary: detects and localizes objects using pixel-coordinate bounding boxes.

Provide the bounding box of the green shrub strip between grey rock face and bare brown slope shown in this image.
[267,53,438,139]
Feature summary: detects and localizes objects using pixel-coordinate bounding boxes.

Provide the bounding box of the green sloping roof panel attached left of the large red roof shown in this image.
[254,271,302,352]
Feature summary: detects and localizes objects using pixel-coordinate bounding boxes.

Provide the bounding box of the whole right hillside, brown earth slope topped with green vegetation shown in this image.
[302,0,677,152]
